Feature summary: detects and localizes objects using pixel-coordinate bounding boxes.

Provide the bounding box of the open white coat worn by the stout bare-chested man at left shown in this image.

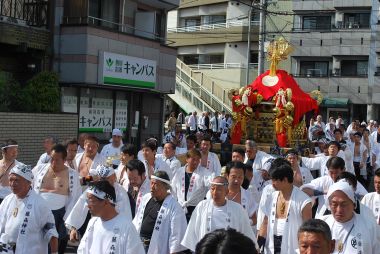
[33,163,82,220]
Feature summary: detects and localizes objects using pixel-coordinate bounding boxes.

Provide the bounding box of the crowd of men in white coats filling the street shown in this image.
[0,112,380,254]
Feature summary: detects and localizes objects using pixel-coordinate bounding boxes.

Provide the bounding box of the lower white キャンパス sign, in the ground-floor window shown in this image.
[79,97,113,132]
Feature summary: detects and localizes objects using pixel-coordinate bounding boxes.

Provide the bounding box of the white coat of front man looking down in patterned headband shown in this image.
[77,214,145,254]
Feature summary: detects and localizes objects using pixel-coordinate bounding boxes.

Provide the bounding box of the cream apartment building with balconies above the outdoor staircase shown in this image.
[167,0,259,88]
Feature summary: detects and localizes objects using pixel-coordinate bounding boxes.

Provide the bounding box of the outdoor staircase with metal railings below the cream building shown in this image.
[169,59,231,113]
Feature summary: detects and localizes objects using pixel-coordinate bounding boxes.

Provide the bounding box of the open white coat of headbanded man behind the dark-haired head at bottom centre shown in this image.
[181,200,257,251]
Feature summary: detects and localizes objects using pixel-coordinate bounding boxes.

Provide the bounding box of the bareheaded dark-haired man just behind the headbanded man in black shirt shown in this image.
[141,139,173,179]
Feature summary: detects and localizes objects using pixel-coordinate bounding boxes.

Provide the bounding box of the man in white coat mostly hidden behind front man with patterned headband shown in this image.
[65,165,132,241]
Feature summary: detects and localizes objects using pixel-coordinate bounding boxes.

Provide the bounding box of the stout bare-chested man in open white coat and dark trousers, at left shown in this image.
[33,144,82,254]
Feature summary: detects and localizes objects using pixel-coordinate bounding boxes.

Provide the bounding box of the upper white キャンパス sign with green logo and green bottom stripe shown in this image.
[98,51,157,89]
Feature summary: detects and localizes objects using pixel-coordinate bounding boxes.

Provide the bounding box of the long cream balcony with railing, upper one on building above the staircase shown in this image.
[167,20,259,47]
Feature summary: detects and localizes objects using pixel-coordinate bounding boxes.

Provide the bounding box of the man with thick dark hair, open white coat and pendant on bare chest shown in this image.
[258,159,312,254]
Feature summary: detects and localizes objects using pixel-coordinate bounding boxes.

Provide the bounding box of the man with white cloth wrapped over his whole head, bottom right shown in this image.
[321,181,380,254]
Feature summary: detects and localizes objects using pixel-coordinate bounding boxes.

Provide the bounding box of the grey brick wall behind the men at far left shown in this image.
[0,112,78,165]
